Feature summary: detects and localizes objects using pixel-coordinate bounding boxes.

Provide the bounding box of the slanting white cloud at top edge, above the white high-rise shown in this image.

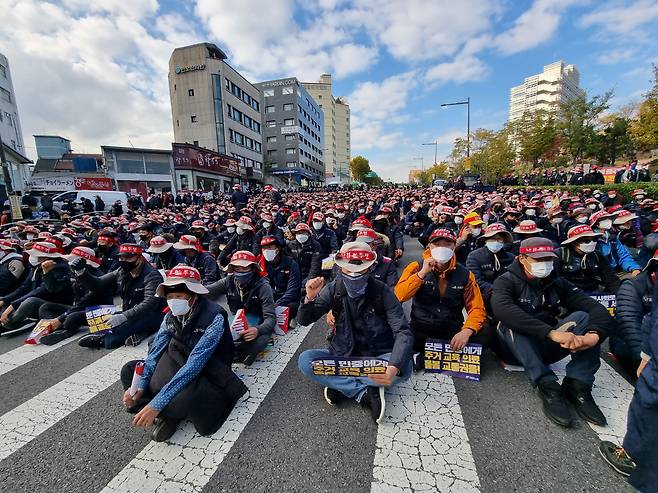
[495,0,582,54]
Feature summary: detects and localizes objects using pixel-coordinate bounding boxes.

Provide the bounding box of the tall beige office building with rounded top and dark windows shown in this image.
[169,43,263,184]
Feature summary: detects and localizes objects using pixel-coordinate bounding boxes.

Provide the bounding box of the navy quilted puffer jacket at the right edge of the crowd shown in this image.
[615,271,654,358]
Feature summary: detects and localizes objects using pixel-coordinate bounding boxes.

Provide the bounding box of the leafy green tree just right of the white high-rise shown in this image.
[557,91,613,162]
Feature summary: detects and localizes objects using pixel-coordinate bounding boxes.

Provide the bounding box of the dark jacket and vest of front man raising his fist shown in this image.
[297,278,414,369]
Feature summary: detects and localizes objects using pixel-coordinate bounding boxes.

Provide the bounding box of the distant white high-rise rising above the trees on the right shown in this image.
[509,60,585,121]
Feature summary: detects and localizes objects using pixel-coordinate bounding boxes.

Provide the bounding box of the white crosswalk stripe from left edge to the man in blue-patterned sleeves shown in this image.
[0,343,146,460]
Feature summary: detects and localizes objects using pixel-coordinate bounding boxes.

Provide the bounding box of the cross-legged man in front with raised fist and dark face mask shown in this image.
[297,242,413,423]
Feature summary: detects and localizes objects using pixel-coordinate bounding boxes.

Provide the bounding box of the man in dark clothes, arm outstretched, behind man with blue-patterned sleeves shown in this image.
[71,243,164,349]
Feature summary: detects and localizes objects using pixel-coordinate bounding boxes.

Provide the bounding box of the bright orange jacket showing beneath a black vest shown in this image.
[395,249,487,332]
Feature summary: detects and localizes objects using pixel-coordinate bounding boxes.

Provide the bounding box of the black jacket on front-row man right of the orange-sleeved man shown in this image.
[491,259,615,340]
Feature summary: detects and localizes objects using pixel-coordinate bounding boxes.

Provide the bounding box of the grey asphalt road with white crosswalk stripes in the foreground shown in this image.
[0,239,633,493]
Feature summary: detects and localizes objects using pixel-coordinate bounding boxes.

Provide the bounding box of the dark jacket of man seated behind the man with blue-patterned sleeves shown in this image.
[79,262,166,320]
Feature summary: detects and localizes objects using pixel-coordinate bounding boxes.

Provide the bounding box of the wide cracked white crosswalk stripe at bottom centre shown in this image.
[371,373,480,493]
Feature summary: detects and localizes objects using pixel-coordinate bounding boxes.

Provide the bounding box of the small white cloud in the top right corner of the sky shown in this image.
[580,0,658,34]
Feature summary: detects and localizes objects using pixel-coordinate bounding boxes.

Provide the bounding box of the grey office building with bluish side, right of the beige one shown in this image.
[256,77,325,184]
